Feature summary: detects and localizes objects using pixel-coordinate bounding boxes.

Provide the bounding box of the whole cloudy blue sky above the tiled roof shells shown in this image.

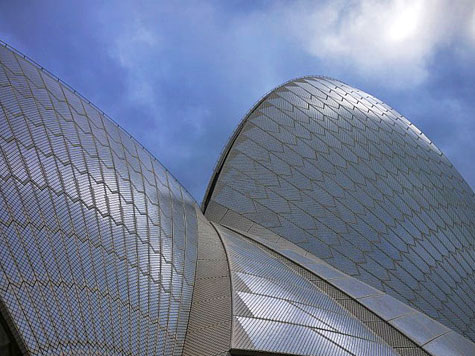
[0,0,475,202]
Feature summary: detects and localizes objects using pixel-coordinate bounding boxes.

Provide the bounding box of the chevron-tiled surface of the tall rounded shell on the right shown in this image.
[204,77,475,340]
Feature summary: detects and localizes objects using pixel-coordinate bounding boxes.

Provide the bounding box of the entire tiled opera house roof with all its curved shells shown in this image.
[0,40,475,355]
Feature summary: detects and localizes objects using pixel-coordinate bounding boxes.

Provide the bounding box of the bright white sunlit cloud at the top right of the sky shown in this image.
[287,0,475,88]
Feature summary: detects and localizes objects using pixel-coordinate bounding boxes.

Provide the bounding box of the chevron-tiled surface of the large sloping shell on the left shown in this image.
[0,46,197,355]
